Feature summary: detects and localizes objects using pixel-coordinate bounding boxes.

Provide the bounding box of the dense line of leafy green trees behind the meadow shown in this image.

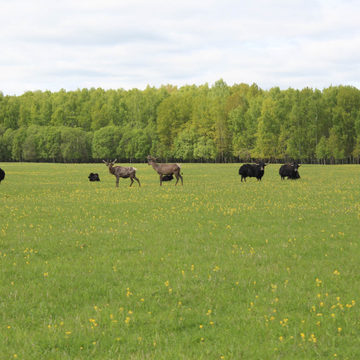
[0,80,360,163]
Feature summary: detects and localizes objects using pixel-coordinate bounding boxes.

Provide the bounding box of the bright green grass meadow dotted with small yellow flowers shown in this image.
[0,163,360,360]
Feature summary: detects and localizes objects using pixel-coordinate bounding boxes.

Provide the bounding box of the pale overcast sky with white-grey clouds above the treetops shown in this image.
[0,0,360,95]
